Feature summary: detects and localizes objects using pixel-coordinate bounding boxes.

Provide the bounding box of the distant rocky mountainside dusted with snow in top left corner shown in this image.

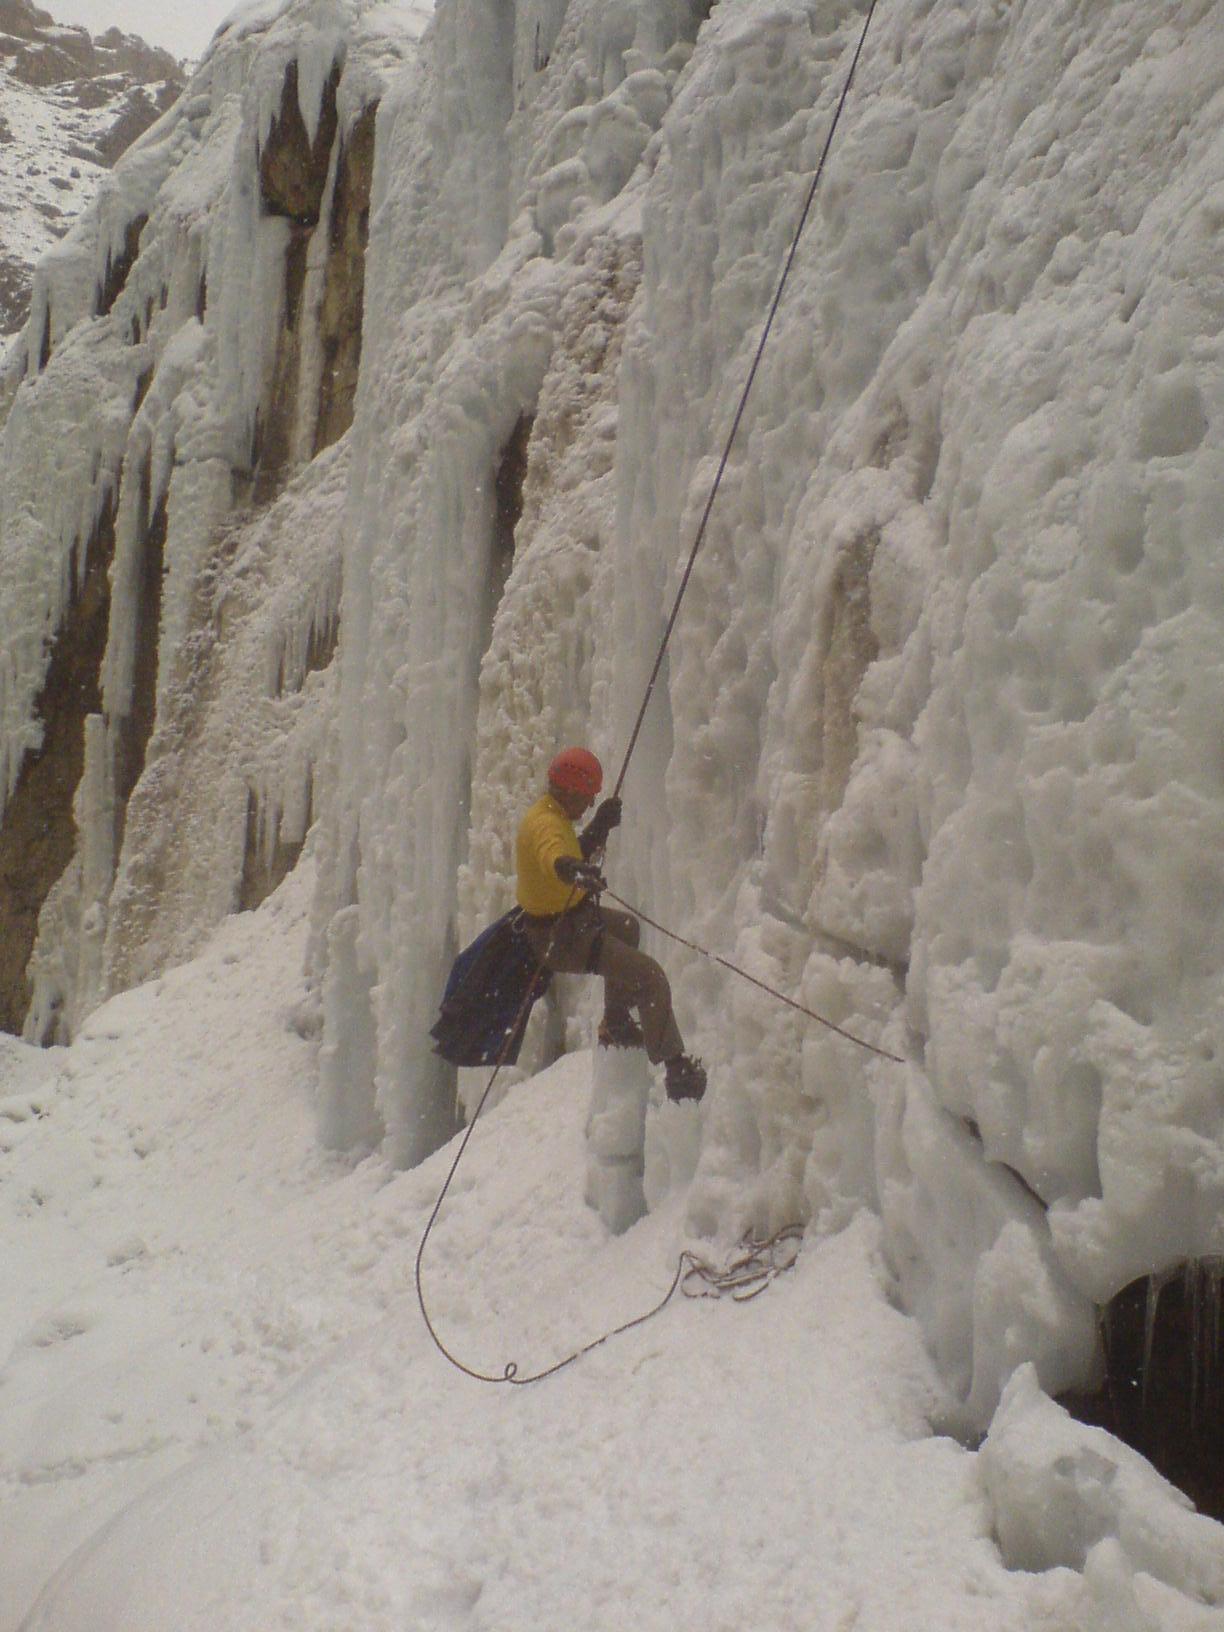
[0,0,184,335]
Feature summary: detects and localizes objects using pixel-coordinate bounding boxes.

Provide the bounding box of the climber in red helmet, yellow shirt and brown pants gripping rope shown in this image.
[516,747,705,1100]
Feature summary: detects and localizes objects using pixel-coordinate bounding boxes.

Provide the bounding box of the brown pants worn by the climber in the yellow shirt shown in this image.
[524,899,684,1064]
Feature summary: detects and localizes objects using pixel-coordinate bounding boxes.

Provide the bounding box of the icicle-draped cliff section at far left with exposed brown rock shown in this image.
[0,0,428,1040]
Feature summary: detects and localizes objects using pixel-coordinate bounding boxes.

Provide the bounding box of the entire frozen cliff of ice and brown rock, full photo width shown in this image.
[0,0,1224,1627]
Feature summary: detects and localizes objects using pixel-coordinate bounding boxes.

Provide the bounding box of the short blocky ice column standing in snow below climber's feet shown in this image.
[586,1048,650,1235]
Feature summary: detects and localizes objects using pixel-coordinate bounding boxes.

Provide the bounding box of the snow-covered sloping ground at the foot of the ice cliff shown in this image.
[0,867,1219,1632]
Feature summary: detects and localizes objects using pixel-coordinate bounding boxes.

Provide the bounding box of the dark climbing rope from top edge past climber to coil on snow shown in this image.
[415,0,901,1386]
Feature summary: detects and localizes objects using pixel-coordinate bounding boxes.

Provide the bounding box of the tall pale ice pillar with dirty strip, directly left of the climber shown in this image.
[318,0,698,1162]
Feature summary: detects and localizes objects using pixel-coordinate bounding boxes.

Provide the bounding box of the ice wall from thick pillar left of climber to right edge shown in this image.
[317,0,1224,1425]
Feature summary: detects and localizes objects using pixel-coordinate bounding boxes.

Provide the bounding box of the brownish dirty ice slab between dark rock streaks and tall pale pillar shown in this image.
[98,444,348,984]
